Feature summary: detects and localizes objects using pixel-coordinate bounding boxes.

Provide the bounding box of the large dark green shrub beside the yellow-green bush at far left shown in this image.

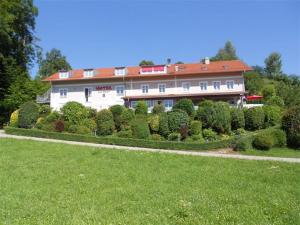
[18,102,39,128]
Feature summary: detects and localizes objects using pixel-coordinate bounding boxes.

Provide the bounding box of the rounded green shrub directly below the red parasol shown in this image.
[244,107,265,130]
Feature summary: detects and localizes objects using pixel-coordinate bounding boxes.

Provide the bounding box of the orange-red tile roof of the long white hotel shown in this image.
[44,60,252,81]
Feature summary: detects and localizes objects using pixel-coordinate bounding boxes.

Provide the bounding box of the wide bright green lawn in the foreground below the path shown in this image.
[0,139,300,225]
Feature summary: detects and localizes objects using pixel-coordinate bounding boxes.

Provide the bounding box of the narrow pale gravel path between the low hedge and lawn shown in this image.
[0,130,300,163]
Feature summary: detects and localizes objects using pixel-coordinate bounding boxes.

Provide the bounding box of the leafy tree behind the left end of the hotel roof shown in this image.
[38,48,72,79]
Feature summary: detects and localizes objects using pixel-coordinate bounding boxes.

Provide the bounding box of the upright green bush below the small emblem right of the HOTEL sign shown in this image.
[96,109,115,135]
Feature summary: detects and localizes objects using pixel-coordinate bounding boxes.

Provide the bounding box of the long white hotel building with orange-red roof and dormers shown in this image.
[38,59,251,110]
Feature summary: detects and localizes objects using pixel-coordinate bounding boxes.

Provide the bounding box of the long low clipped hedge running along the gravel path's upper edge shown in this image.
[4,127,233,151]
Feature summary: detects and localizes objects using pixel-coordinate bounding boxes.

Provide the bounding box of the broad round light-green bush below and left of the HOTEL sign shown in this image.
[61,102,89,125]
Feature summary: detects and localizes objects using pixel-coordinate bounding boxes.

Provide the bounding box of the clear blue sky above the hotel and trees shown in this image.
[31,0,300,76]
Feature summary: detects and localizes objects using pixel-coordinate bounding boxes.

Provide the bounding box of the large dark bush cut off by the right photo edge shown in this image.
[282,106,300,148]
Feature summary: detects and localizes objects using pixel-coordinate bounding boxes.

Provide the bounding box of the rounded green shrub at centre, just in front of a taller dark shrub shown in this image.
[168,110,189,132]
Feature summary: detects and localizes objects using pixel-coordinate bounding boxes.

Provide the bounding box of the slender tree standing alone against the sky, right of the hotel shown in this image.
[265,52,282,78]
